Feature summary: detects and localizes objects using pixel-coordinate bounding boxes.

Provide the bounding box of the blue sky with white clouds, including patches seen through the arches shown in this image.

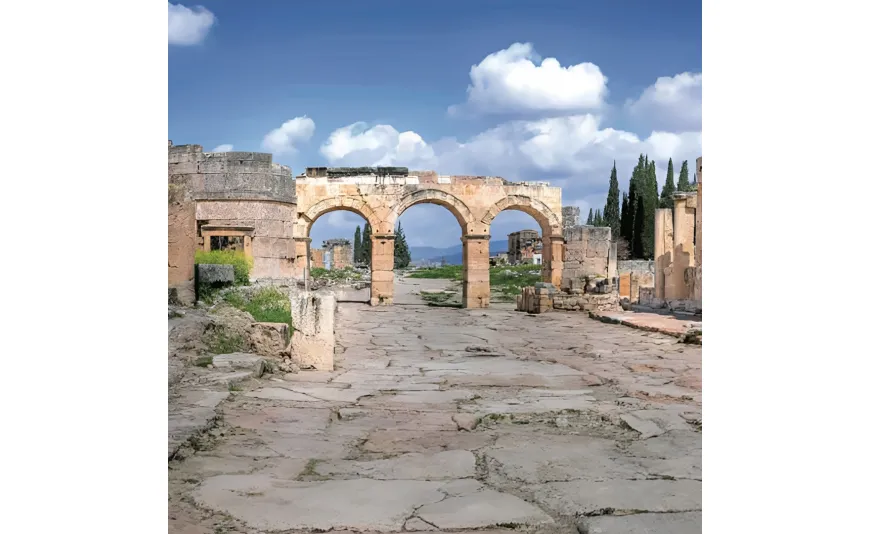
[169,0,701,251]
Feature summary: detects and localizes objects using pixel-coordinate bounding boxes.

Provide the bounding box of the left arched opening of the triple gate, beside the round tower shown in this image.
[301,206,372,302]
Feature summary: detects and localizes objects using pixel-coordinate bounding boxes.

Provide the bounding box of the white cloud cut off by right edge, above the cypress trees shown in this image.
[625,72,701,130]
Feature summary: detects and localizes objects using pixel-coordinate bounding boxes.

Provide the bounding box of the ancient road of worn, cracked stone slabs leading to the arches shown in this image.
[169,286,701,534]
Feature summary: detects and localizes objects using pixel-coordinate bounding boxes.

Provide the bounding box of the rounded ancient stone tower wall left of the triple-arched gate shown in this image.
[194,152,297,279]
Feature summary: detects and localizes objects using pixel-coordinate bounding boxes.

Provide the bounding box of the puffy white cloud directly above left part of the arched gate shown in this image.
[320,122,434,167]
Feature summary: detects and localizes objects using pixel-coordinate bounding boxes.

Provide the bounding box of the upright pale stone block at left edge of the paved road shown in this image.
[290,291,336,371]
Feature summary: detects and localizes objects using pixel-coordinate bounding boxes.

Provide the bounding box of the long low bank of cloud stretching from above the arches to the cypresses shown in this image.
[321,114,701,216]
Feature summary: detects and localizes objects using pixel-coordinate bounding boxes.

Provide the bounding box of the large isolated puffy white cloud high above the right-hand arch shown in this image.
[448,43,607,113]
